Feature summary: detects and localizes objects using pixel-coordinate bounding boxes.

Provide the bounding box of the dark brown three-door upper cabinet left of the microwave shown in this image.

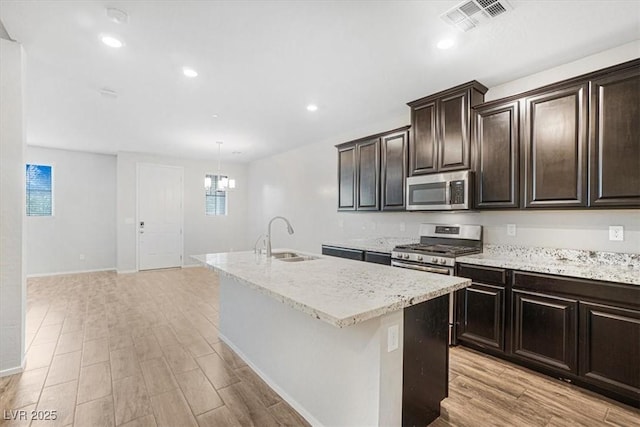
[336,126,409,211]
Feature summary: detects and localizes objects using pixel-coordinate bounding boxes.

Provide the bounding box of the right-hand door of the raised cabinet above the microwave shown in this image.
[438,90,470,171]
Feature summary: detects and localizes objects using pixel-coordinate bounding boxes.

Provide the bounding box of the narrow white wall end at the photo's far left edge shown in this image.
[0,39,26,377]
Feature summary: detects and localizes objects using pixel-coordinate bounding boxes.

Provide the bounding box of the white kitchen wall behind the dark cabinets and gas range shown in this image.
[249,41,640,253]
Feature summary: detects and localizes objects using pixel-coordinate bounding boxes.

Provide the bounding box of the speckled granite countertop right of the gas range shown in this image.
[456,244,640,285]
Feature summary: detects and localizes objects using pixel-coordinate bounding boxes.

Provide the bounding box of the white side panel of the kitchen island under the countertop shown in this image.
[220,274,402,426]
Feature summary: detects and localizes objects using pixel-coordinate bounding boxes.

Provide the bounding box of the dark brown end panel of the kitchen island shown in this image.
[402,295,449,426]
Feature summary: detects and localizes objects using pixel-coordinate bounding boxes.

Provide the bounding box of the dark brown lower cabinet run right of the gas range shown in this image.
[456,264,640,408]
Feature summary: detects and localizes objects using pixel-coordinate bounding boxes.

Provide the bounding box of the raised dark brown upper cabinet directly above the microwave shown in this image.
[408,80,487,175]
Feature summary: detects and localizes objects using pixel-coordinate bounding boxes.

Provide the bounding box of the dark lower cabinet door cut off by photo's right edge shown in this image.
[580,302,640,402]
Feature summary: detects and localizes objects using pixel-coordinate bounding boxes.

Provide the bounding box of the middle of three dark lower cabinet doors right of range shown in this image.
[512,289,578,374]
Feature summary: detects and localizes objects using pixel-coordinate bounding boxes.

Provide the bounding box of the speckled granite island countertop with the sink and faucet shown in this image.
[193,249,471,327]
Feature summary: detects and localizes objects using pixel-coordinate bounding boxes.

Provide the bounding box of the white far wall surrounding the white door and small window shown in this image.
[116,152,249,273]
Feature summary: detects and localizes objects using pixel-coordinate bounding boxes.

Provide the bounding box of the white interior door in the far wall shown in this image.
[136,163,183,270]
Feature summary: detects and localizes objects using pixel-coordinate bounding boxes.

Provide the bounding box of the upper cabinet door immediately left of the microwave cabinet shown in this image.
[381,132,409,211]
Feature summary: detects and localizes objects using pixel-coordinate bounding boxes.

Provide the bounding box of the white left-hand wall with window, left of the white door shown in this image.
[26,146,116,275]
